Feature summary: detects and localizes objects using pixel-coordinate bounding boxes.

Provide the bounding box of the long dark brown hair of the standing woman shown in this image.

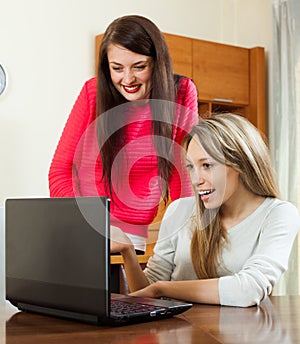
[96,15,176,201]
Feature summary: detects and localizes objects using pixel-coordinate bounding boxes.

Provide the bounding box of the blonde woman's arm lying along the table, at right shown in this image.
[133,202,299,307]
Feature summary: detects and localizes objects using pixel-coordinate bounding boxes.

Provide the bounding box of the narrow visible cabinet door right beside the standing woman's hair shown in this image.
[163,33,193,78]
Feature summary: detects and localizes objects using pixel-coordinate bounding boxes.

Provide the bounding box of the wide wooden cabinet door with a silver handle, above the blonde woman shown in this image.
[193,40,249,105]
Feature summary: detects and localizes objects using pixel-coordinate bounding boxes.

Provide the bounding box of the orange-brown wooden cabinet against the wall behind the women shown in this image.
[95,33,266,135]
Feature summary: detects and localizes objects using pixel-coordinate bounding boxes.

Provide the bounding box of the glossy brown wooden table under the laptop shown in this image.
[0,296,300,344]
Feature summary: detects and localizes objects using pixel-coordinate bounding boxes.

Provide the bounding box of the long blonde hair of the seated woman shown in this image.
[183,113,279,278]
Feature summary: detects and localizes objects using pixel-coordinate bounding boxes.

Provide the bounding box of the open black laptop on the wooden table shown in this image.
[5,197,192,325]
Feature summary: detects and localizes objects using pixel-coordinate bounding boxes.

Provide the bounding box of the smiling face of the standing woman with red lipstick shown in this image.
[107,44,153,101]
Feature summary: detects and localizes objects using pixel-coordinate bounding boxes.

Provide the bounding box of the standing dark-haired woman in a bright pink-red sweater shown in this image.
[49,15,198,251]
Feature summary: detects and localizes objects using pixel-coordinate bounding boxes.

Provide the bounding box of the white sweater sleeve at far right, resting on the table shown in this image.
[219,202,300,307]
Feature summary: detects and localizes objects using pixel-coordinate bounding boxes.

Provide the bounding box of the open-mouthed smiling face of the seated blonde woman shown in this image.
[186,137,241,209]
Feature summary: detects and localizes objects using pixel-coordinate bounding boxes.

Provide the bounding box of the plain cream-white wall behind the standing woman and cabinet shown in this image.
[0,0,271,206]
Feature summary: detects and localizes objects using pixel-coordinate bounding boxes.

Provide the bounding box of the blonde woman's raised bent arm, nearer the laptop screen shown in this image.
[111,197,197,291]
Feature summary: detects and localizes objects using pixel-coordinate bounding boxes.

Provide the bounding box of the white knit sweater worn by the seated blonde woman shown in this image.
[144,197,300,307]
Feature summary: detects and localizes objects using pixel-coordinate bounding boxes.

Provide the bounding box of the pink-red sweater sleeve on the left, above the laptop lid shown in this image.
[48,78,96,197]
